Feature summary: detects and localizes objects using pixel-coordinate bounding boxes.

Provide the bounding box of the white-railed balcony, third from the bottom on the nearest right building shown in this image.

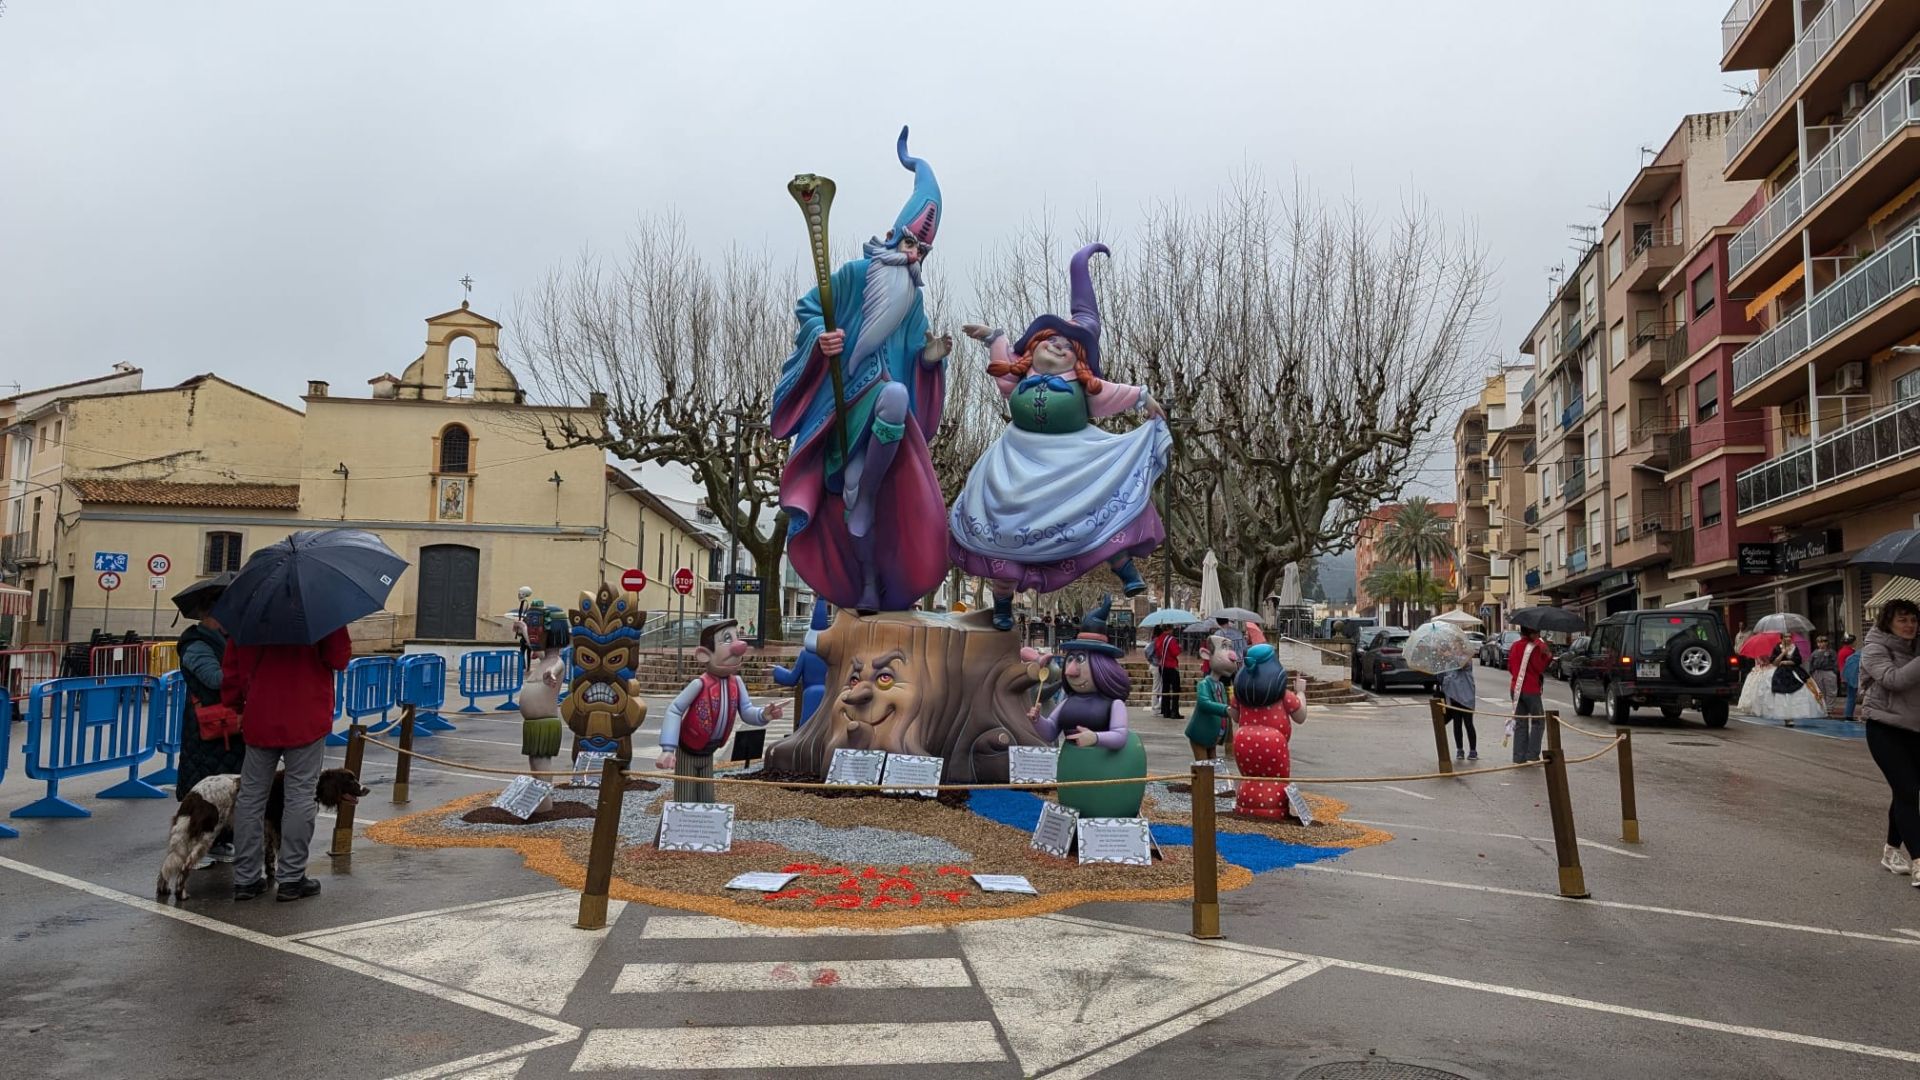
[1726,69,1920,292]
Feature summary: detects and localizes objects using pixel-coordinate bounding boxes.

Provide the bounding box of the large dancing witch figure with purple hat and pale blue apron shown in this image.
[948,244,1173,630]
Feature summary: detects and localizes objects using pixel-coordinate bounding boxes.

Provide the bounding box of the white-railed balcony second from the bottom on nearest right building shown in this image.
[1734,227,1920,407]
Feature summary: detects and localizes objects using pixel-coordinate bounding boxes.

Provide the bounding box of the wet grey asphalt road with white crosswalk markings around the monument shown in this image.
[0,671,1920,1080]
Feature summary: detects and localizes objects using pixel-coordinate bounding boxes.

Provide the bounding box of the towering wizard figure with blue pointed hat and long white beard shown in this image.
[772,127,952,611]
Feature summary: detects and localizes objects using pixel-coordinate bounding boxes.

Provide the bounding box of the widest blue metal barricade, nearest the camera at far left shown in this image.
[13,675,167,817]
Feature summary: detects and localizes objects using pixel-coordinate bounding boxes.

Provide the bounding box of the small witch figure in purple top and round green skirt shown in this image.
[1033,596,1146,817]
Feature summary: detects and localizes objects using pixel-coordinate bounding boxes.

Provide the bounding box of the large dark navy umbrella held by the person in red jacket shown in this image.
[213,528,407,646]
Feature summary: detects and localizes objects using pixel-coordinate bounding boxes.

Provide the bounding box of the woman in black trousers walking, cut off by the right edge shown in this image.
[1860,600,1920,888]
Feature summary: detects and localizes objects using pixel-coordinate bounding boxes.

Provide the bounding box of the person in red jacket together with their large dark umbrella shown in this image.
[213,528,407,899]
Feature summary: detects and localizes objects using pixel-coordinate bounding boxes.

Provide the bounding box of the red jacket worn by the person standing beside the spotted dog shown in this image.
[221,626,353,749]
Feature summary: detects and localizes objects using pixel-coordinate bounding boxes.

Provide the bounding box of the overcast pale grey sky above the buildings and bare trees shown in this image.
[0,0,1738,495]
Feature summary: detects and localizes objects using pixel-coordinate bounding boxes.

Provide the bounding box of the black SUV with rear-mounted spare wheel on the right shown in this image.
[1572,611,1740,728]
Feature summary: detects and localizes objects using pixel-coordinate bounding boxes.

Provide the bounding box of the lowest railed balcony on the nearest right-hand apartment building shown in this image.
[1734,390,1920,525]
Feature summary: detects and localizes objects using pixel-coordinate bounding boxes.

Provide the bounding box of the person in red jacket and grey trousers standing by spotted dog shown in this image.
[221,626,353,899]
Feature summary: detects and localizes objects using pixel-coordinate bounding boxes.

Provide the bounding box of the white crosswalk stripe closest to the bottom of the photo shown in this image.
[572,1020,1006,1072]
